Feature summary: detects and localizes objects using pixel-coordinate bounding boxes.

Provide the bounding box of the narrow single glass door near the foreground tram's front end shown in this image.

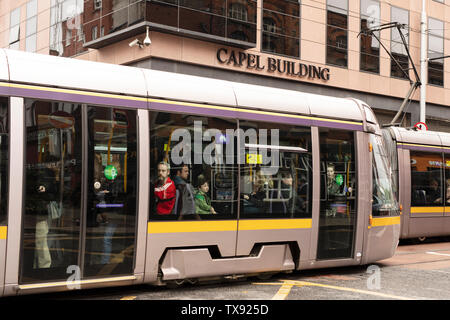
[317,128,357,259]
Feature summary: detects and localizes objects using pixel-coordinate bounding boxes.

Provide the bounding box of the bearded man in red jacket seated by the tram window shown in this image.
[154,162,176,215]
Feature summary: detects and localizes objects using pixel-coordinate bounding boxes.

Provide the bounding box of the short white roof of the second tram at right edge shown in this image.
[390,127,450,147]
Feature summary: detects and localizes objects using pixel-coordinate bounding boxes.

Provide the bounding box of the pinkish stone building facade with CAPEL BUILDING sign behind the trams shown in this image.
[0,0,450,132]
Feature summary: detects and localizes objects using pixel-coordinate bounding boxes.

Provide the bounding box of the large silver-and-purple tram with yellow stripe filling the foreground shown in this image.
[0,50,400,296]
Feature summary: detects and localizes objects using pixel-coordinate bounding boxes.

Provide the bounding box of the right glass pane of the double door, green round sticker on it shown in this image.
[84,106,137,277]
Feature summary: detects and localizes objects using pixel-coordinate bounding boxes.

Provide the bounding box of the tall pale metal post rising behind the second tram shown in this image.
[419,0,428,123]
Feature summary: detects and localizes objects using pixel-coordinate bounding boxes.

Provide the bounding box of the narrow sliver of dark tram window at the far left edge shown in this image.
[0,98,9,225]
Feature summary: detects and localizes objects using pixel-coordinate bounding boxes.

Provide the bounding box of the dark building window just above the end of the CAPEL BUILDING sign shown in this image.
[327,0,348,67]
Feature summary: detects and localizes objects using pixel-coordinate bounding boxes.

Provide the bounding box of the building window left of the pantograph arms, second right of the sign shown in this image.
[360,0,380,73]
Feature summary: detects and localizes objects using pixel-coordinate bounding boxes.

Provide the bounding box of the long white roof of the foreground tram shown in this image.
[0,49,365,121]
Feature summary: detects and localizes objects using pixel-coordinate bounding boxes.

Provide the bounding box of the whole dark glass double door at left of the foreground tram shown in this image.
[19,99,136,284]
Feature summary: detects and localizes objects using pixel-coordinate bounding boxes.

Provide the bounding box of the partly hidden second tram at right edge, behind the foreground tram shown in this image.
[383,127,450,242]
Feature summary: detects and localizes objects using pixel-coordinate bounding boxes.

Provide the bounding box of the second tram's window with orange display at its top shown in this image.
[410,151,443,206]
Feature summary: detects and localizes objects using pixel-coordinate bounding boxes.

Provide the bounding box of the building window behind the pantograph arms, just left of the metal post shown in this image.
[391,7,409,79]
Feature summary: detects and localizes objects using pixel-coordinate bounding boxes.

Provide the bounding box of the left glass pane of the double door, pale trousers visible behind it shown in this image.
[20,99,82,283]
